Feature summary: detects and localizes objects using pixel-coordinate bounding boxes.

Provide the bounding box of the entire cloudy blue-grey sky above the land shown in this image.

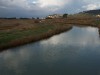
[0,0,100,17]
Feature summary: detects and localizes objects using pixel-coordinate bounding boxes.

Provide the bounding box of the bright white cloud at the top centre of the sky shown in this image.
[32,0,71,12]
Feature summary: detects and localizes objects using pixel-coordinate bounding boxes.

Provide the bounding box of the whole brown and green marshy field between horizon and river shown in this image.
[0,14,100,50]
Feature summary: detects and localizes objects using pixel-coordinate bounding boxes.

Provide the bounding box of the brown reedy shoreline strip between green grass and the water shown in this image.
[0,20,72,51]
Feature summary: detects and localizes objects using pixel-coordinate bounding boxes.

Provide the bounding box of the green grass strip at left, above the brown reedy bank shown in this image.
[0,26,52,44]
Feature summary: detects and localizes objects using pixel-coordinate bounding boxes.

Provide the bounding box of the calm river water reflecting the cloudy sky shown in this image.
[0,26,100,75]
